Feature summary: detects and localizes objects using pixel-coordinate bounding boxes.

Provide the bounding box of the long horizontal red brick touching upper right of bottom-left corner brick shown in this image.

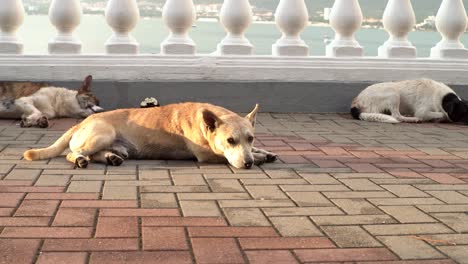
[42,238,138,252]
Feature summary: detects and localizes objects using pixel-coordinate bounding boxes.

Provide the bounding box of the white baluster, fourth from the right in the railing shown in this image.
[272,0,309,56]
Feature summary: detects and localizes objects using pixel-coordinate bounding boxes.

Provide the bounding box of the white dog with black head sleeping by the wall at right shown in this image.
[351,79,468,123]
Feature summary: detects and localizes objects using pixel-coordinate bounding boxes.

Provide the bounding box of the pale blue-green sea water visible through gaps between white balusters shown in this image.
[18,15,468,57]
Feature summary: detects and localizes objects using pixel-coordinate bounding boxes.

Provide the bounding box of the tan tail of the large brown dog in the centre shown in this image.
[23,125,78,161]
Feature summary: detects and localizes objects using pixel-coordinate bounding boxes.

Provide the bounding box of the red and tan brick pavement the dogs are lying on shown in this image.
[0,114,468,264]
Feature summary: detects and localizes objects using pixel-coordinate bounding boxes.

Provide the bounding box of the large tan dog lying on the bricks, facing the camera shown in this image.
[24,103,277,169]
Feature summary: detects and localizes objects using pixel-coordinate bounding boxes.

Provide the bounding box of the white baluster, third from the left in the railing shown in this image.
[105,0,140,54]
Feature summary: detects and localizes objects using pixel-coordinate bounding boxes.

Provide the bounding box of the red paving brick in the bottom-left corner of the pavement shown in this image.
[0,239,41,263]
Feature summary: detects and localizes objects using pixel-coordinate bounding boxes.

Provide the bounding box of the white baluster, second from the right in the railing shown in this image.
[379,0,417,58]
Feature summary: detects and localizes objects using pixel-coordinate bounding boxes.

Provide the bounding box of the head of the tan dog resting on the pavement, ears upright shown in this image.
[202,105,258,169]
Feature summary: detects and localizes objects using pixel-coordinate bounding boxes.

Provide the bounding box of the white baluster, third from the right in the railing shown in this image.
[326,0,364,57]
